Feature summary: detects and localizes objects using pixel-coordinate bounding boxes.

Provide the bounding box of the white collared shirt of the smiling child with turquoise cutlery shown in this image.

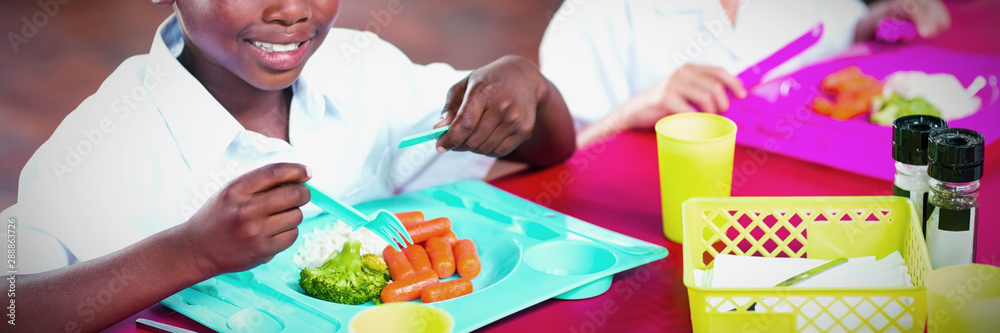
[2,16,494,274]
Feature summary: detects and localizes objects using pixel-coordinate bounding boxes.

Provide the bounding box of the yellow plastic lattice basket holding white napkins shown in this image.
[682,196,931,333]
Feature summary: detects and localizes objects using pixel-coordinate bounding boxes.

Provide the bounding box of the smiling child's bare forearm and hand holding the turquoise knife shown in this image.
[435,56,576,166]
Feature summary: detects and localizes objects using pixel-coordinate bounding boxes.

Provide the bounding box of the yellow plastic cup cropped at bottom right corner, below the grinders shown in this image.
[927,264,1000,333]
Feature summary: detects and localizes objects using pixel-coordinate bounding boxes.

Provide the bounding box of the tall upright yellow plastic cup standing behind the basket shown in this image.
[655,112,736,243]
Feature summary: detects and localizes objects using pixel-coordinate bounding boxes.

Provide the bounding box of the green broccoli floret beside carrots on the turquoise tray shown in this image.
[299,240,389,305]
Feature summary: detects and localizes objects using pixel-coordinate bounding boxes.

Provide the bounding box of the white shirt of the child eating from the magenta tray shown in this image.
[539,0,866,126]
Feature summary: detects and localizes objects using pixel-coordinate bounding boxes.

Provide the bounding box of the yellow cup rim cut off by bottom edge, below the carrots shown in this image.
[348,302,455,333]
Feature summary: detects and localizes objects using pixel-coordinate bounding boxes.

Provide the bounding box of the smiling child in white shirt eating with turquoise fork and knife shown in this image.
[3,0,575,331]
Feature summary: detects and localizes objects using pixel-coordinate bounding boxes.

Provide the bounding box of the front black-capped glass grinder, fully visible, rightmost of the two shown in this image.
[927,128,985,269]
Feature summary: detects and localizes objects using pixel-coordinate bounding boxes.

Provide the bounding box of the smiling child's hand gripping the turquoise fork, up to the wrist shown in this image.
[175,163,311,276]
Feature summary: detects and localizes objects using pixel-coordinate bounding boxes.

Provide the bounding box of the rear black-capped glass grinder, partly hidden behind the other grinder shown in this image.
[892,115,948,231]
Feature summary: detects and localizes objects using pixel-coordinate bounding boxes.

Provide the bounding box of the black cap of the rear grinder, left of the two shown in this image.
[892,115,948,165]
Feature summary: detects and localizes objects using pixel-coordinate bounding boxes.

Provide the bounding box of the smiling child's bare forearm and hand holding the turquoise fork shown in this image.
[11,163,310,332]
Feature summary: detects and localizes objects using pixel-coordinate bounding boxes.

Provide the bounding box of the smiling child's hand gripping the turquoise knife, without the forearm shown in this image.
[434,56,547,157]
